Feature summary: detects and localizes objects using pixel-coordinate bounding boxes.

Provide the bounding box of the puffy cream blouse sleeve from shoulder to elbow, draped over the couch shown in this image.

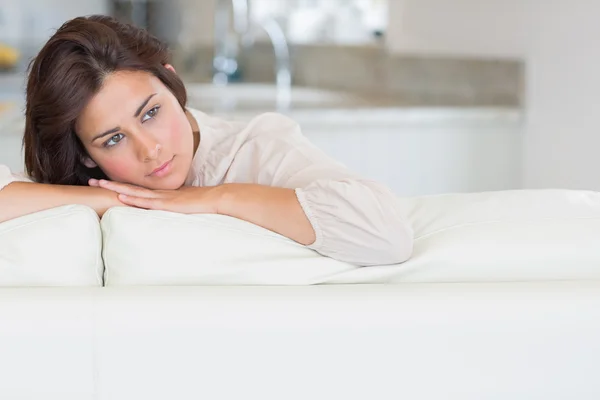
[241,114,413,266]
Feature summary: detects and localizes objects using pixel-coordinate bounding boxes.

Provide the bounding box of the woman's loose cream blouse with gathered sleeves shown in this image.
[0,109,413,266]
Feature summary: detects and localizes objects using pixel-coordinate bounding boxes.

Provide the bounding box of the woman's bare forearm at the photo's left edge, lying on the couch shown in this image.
[0,182,123,223]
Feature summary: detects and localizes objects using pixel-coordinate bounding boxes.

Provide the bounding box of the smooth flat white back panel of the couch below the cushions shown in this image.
[0,282,600,400]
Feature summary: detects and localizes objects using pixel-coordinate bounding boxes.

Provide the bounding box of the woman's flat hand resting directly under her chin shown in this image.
[89,179,221,214]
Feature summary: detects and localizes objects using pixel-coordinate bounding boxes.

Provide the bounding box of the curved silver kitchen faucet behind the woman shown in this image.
[213,0,292,111]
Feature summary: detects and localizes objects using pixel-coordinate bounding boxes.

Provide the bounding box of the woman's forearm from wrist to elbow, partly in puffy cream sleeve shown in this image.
[213,179,413,265]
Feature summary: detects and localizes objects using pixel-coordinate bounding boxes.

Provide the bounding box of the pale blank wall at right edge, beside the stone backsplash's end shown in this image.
[523,0,600,190]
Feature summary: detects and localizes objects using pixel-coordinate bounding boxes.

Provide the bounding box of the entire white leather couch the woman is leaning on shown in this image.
[0,190,600,400]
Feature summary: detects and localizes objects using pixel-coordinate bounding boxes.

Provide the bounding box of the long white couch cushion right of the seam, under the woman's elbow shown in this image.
[102,190,600,285]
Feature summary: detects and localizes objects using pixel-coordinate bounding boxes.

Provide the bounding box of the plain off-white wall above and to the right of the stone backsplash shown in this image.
[387,0,600,190]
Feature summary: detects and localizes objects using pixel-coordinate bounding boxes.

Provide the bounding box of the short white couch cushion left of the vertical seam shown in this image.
[0,205,104,286]
